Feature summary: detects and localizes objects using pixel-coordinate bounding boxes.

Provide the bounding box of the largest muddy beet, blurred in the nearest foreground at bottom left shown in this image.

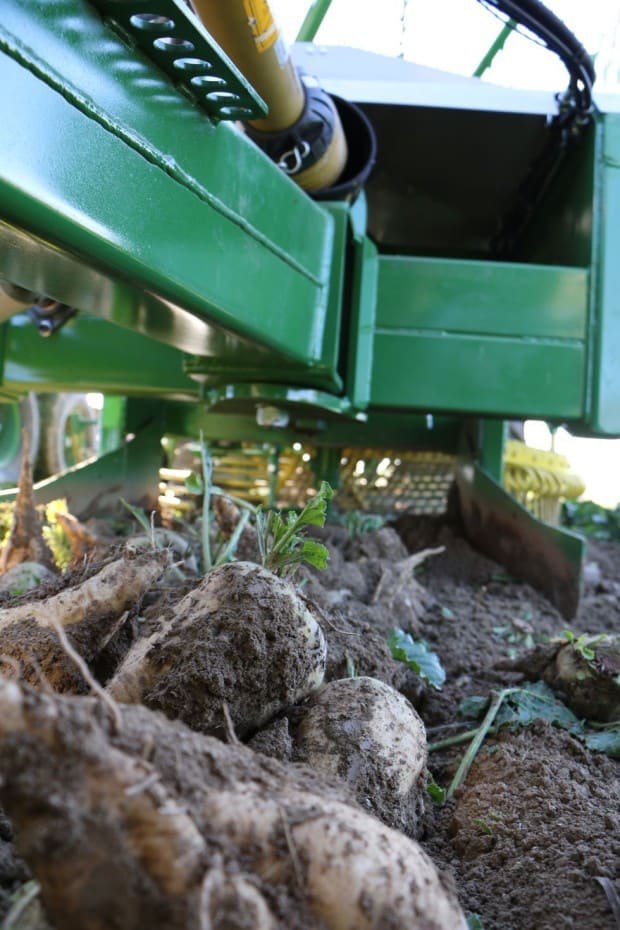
[0,677,466,930]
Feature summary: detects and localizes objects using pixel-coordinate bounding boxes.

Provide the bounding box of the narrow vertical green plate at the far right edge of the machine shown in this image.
[591,114,620,435]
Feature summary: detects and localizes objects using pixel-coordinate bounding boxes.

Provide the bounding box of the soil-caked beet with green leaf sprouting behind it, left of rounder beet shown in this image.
[108,562,326,737]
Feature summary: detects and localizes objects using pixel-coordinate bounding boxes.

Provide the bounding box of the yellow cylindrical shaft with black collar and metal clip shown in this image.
[192,0,347,191]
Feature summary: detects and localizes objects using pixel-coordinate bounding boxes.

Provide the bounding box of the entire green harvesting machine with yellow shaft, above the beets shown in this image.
[0,0,620,615]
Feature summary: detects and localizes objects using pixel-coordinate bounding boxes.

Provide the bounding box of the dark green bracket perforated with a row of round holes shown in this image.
[90,0,267,120]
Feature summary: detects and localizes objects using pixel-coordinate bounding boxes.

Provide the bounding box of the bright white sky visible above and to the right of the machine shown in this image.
[271,0,620,507]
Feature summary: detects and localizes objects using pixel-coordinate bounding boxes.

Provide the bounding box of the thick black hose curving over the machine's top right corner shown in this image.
[479,0,596,114]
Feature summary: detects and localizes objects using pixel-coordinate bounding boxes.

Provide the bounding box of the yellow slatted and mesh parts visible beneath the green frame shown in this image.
[160,440,585,524]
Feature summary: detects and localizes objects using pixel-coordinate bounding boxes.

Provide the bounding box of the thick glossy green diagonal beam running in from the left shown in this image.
[0,2,344,388]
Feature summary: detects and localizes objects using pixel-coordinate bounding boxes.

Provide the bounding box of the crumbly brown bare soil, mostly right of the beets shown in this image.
[0,518,620,930]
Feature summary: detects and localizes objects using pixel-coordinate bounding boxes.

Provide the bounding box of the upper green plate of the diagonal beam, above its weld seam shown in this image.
[0,0,314,276]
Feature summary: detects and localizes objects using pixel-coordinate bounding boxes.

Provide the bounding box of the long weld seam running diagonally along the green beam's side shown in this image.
[0,30,326,288]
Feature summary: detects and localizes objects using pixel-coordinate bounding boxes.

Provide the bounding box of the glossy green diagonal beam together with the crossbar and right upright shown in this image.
[0,0,620,433]
